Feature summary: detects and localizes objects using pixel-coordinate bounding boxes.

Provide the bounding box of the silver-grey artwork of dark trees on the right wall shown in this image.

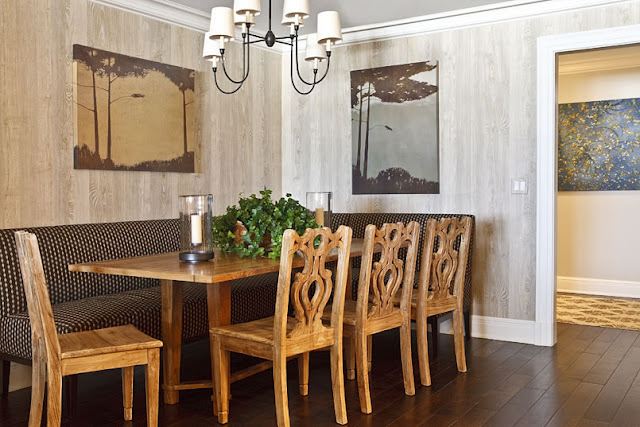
[351,61,440,194]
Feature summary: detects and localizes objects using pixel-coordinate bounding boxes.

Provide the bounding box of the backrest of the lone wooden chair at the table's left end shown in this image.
[15,231,60,363]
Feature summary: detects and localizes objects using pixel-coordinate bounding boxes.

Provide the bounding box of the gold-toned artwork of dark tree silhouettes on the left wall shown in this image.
[73,45,196,173]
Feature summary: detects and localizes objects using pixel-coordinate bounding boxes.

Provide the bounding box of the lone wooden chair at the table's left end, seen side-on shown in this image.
[15,231,162,427]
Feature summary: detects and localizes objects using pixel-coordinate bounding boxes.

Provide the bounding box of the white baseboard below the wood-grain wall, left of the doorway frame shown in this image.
[438,315,535,344]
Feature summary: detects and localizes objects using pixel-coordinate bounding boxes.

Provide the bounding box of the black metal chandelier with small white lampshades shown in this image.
[202,0,342,95]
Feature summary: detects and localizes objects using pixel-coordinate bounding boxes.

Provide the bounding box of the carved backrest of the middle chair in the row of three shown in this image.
[356,221,420,320]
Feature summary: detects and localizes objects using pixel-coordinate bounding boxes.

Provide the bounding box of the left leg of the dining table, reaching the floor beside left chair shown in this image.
[161,280,182,405]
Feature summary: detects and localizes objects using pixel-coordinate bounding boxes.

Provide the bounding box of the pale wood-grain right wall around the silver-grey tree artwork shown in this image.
[282,2,640,320]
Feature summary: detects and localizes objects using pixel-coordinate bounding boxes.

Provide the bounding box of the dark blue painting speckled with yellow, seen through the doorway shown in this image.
[558,98,640,191]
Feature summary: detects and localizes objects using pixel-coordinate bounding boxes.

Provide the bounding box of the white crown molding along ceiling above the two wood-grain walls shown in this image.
[90,0,636,54]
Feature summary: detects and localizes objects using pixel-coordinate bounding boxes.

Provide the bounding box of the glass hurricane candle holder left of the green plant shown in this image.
[179,194,213,262]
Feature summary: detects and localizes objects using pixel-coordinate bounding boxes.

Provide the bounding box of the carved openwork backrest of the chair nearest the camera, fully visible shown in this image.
[274,226,351,345]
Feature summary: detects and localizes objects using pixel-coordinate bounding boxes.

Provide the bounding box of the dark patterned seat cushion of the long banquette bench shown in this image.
[0,273,278,359]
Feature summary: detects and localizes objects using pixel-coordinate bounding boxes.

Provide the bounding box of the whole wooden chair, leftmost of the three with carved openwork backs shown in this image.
[210,226,352,426]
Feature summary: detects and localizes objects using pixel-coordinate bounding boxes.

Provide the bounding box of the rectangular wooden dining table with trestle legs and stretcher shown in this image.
[69,239,364,405]
